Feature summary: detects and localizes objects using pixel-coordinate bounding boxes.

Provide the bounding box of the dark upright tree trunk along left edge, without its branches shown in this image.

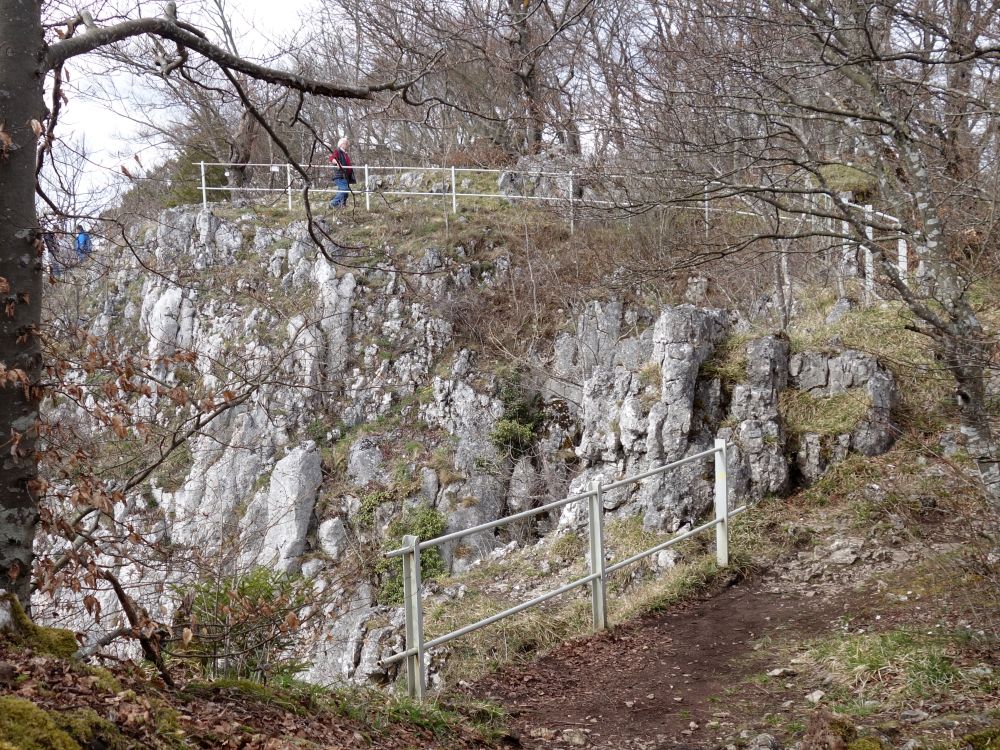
[0,0,45,610]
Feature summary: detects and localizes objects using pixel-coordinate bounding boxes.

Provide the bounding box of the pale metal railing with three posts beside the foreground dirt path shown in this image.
[382,440,747,698]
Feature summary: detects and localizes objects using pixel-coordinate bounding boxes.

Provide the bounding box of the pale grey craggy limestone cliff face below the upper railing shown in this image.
[37,204,896,682]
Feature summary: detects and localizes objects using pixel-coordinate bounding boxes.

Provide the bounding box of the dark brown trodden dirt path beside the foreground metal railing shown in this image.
[474,582,844,749]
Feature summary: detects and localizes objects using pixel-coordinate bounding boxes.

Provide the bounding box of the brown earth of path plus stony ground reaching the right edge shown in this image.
[466,506,1000,750]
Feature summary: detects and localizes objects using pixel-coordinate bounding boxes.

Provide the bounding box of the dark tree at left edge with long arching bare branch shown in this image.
[0,0,426,606]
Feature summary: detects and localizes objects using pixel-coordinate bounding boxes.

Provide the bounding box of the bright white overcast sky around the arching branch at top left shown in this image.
[58,0,313,206]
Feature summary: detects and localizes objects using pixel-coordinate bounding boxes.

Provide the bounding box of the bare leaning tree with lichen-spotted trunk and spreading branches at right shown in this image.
[612,0,1000,513]
